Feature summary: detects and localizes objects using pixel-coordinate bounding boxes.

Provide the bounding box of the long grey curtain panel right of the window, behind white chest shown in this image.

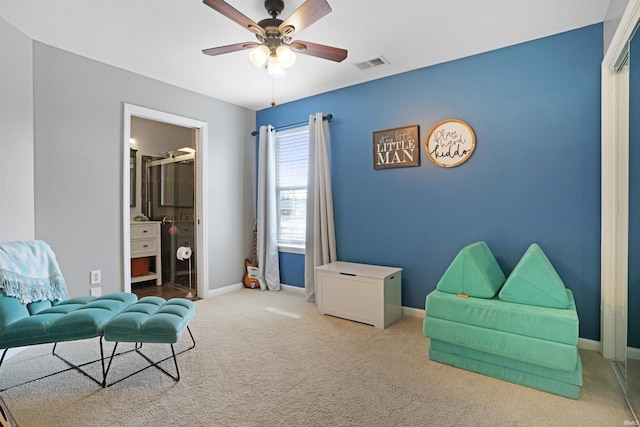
[304,113,338,301]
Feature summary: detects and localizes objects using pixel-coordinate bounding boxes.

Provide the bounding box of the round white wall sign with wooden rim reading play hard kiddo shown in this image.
[425,119,476,168]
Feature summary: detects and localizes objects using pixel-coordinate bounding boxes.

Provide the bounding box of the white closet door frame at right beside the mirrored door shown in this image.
[600,0,640,361]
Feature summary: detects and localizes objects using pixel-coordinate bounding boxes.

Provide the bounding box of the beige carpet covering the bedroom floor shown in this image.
[0,288,633,427]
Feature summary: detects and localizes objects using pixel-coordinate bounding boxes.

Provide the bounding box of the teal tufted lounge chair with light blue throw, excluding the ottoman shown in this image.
[0,240,138,392]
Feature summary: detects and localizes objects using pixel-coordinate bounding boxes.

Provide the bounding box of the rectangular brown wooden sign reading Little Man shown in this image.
[373,125,420,169]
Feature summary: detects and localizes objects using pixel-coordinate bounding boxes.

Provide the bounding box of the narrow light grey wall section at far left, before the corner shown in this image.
[0,18,34,242]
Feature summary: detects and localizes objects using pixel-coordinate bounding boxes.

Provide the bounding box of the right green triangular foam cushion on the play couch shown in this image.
[498,243,569,308]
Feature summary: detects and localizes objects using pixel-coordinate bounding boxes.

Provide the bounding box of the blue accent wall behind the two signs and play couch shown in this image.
[256,24,603,340]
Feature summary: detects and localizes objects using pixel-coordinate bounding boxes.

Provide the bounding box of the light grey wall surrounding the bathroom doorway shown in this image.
[33,42,255,296]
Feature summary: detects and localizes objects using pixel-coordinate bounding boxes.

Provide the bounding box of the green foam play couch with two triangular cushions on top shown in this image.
[423,242,582,399]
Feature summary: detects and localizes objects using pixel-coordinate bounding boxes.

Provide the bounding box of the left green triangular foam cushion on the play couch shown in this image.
[437,242,505,298]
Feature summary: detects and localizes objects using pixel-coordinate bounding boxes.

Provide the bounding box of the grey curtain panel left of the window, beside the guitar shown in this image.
[256,125,280,291]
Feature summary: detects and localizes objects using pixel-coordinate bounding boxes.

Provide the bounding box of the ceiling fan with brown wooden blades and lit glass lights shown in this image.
[202,0,347,75]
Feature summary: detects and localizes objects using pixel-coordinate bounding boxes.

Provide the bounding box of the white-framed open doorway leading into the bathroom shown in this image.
[123,104,208,298]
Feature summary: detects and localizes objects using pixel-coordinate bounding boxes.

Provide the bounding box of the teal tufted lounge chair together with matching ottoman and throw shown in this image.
[0,241,196,391]
